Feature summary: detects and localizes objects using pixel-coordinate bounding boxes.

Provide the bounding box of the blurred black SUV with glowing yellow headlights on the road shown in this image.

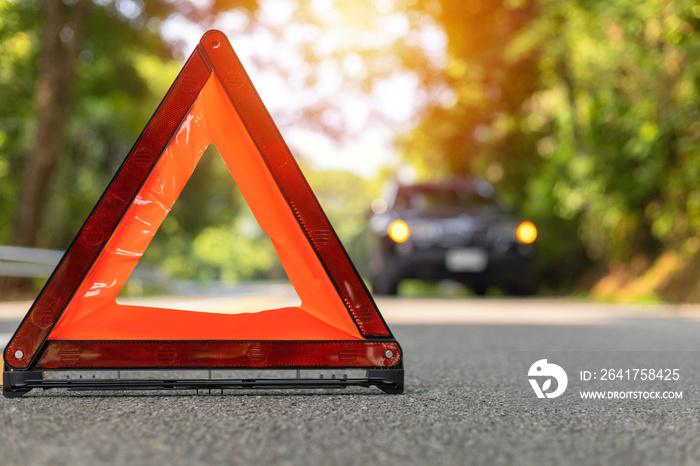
[369,177,538,295]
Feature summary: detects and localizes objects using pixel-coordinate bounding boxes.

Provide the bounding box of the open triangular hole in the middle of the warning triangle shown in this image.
[117,145,301,314]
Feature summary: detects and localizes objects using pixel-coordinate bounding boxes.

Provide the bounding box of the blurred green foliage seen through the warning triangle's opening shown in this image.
[140,146,276,282]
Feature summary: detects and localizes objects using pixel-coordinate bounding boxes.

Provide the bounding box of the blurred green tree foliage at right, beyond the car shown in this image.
[514,1,700,261]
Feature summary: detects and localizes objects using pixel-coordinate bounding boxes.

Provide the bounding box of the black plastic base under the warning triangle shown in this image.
[2,367,404,398]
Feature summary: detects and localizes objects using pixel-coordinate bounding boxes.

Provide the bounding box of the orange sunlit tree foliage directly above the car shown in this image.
[404,0,537,175]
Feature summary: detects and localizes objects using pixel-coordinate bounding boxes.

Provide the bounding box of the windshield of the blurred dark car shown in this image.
[394,185,496,210]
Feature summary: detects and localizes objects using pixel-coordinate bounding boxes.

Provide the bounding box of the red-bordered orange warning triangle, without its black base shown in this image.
[4,31,402,394]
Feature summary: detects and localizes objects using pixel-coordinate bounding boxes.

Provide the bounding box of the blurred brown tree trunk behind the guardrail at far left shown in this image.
[1,0,92,297]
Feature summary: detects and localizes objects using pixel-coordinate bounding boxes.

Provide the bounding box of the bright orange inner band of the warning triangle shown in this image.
[49,76,362,340]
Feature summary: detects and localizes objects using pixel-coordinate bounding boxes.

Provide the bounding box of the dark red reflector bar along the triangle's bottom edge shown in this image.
[36,341,401,369]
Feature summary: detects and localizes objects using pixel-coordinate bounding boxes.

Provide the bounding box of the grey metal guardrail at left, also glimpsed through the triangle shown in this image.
[0,246,168,286]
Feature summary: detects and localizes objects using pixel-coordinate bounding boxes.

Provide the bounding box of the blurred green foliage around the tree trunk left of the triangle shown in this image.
[0,0,256,248]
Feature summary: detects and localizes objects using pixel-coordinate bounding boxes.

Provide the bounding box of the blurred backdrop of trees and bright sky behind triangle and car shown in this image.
[0,0,700,302]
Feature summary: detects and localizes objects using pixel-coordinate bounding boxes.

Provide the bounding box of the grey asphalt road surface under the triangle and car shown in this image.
[0,295,700,465]
